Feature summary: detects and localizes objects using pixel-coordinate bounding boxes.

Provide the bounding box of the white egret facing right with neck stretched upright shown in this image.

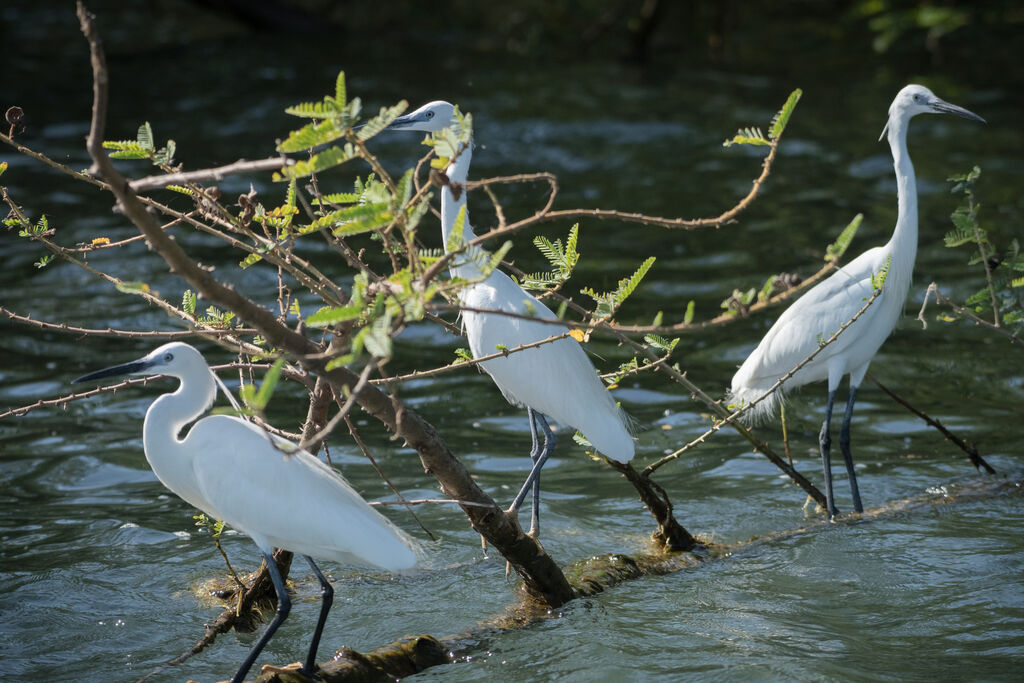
[729,85,984,517]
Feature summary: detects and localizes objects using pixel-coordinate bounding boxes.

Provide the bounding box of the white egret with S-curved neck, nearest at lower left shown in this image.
[75,342,417,681]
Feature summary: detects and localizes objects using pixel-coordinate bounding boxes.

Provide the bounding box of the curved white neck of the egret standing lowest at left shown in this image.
[142,366,217,497]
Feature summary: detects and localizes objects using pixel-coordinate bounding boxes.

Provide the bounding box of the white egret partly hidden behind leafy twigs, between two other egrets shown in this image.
[389,101,635,537]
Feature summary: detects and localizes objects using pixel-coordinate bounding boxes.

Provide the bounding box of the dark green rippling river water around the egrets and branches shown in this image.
[0,6,1024,681]
